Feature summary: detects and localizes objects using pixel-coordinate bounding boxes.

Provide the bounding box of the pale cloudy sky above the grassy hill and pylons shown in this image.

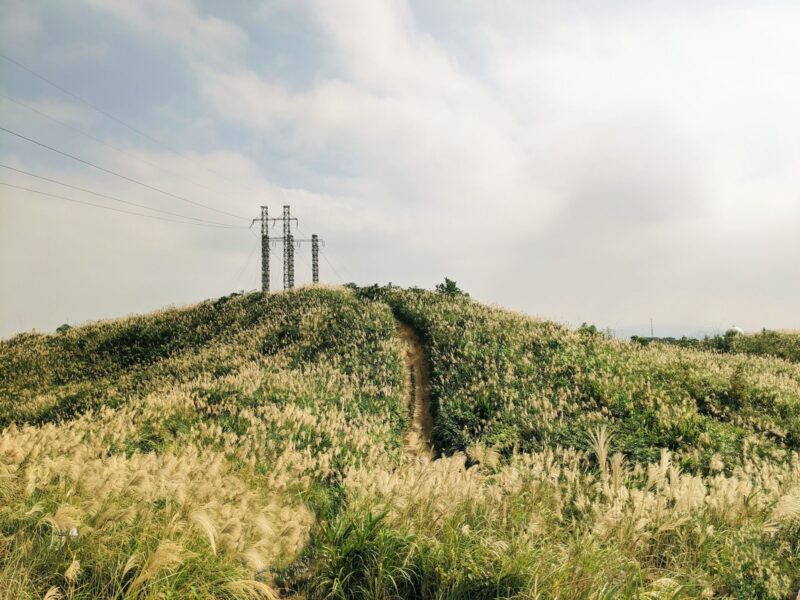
[0,0,800,337]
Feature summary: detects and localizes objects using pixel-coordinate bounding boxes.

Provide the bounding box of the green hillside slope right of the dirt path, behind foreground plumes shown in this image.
[384,290,800,474]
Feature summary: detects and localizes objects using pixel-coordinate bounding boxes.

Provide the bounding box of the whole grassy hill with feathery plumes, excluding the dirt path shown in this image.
[0,287,800,600]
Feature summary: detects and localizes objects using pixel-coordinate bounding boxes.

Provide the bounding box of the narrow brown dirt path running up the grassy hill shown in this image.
[397,321,433,459]
